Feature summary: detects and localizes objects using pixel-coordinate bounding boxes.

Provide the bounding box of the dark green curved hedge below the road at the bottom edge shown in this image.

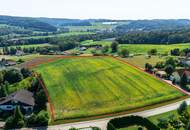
[107,116,160,130]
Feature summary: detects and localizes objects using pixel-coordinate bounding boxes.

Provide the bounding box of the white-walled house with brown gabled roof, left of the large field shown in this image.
[0,89,35,112]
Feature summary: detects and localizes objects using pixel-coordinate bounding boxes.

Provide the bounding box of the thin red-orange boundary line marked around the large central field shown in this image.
[30,56,190,123]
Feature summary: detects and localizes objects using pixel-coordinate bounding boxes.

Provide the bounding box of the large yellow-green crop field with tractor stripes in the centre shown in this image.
[33,57,184,119]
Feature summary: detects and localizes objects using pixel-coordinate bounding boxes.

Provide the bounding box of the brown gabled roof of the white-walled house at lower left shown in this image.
[0,89,35,106]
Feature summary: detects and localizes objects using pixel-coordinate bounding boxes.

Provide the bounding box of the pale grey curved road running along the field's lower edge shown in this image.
[23,98,190,130]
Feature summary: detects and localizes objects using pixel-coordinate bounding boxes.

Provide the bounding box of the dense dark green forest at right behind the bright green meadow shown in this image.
[116,28,190,44]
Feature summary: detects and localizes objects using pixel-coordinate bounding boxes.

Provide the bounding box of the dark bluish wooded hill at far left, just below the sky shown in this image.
[0,15,57,32]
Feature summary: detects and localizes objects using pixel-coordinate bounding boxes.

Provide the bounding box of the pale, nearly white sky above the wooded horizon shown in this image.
[0,0,190,19]
